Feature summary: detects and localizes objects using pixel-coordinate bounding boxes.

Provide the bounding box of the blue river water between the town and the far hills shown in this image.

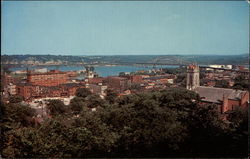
[10,65,179,77]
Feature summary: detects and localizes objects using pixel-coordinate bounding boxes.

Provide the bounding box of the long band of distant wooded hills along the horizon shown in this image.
[1,54,249,65]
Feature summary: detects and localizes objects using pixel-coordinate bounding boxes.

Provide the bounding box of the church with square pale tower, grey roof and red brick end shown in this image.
[187,65,249,114]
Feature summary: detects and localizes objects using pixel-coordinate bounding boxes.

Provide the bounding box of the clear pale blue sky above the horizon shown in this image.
[1,1,249,55]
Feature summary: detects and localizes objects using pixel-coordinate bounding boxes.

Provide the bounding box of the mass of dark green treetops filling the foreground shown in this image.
[0,88,248,158]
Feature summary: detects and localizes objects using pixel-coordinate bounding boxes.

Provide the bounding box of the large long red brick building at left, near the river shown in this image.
[27,70,69,86]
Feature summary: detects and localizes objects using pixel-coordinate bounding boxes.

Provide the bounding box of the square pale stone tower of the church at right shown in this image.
[187,65,200,90]
